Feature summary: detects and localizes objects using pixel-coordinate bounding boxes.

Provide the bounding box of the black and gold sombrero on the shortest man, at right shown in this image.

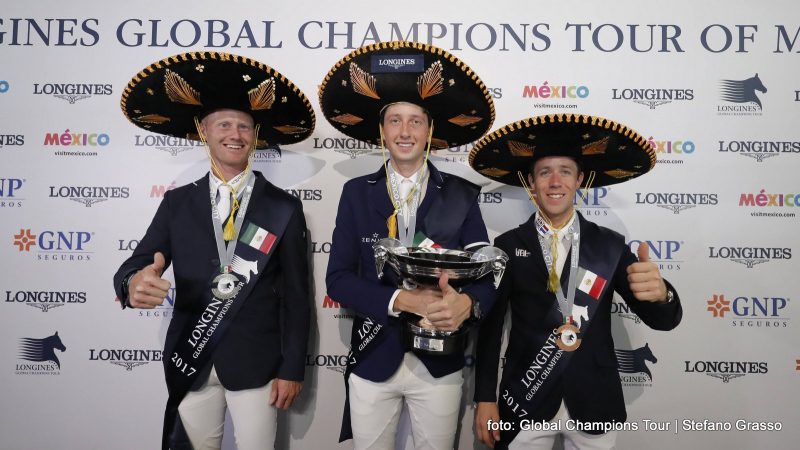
[469,114,656,187]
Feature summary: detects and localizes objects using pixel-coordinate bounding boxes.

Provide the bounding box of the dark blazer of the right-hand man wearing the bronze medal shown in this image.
[475,213,683,434]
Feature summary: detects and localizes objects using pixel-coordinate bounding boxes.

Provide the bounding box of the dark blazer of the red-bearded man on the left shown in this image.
[114,172,311,391]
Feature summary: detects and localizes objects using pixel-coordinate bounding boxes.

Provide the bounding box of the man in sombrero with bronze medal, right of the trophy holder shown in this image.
[470,114,682,449]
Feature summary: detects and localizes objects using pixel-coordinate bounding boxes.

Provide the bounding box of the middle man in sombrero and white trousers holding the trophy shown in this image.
[320,42,494,449]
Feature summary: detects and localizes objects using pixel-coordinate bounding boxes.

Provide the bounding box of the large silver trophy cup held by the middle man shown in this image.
[372,238,508,355]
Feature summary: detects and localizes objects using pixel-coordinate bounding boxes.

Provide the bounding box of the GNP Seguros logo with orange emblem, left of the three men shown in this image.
[13,228,94,262]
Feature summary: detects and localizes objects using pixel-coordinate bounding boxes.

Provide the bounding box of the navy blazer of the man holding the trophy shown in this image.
[325,162,495,382]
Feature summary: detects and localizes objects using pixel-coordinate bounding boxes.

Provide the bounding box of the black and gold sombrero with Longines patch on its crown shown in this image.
[319,41,495,149]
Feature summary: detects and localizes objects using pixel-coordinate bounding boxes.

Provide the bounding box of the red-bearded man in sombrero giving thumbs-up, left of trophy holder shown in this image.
[114,52,314,450]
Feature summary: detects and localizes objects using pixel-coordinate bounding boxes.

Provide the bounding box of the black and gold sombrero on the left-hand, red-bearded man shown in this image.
[120,52,315,148]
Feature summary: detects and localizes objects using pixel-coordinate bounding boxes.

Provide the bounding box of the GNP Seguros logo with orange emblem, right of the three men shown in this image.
[706,294,790,329]
